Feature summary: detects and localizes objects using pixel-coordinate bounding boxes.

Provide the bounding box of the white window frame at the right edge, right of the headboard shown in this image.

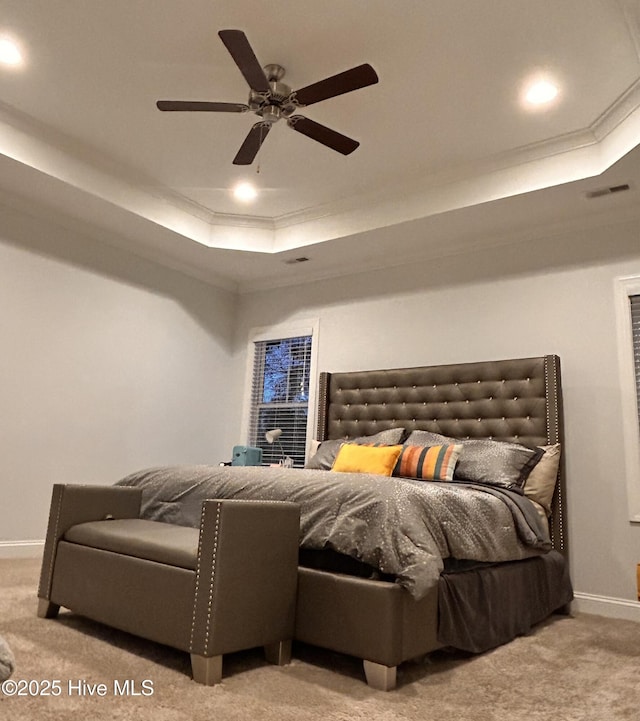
[615,275,640,523]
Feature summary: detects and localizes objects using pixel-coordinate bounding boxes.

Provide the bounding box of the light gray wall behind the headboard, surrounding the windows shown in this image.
[236,212,640,599]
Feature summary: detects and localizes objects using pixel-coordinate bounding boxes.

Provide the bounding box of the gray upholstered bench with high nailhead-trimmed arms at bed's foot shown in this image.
[38,485,300,685]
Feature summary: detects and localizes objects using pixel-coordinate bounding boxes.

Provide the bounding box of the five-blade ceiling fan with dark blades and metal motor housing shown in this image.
[156,30,378,165]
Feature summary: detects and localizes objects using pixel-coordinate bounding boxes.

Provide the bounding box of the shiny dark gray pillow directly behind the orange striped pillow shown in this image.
[406,431,544,492]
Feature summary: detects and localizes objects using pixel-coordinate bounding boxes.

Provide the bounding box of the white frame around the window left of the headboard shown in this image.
[241,318,320,461]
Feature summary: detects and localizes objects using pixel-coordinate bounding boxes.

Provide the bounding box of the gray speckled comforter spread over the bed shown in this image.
[118,466,550,598]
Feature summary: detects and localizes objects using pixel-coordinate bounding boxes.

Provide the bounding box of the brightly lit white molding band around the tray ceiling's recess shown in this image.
[0,69,640,253]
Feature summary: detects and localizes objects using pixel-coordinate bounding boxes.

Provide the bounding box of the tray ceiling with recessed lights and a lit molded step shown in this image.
[0,0,640,291]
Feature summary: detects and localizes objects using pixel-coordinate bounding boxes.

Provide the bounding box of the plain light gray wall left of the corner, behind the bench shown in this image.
[0,210,236,546]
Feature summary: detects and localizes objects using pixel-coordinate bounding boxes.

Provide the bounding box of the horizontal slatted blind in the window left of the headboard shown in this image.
[249,335,312,467]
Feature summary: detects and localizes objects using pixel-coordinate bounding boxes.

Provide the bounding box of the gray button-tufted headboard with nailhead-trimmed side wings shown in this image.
[317,355,568,554]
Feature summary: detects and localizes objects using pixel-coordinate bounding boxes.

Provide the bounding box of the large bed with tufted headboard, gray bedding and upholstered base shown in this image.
[119,355,573,690]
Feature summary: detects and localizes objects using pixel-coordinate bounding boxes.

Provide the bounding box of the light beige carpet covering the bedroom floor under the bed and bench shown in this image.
[0,559,640,721]
